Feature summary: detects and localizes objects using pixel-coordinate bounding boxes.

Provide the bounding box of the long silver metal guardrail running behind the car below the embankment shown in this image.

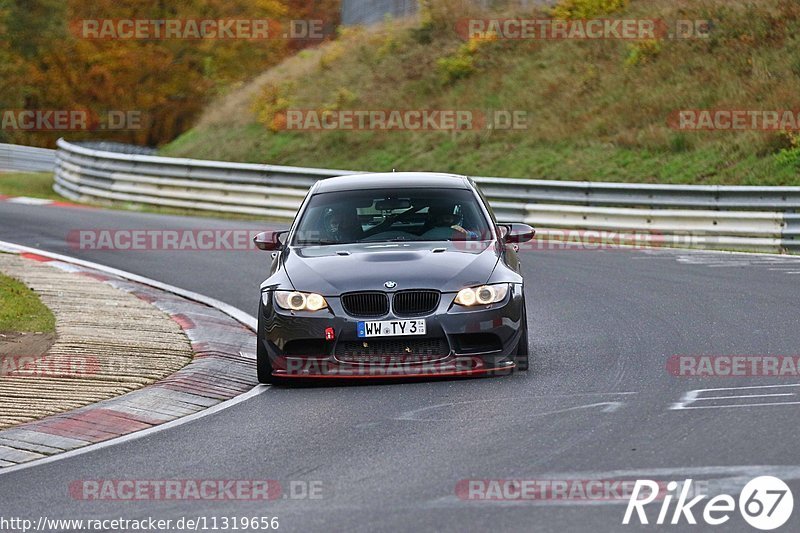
[48,139,800,251]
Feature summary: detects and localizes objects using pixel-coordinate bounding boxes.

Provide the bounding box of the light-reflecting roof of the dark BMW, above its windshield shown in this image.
[314,172,470,194]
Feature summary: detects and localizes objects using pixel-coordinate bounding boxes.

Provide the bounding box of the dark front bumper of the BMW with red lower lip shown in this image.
[258,284,525,378]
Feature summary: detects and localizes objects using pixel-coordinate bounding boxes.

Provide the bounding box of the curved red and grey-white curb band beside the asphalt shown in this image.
[0,242,265,473]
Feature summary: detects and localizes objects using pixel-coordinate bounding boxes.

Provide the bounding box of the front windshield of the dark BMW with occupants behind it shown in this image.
[292,189,491,245]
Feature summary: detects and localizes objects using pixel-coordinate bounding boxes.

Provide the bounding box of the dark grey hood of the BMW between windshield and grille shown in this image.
[283,241,499,296]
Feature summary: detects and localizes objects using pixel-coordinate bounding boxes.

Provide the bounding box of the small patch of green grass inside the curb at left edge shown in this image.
[0,274,56,333]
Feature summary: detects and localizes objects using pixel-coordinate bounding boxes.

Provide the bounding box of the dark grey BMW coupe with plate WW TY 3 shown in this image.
[255,172,534,383]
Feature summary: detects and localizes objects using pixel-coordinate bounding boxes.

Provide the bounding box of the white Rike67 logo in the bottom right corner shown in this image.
[622,476,794,531]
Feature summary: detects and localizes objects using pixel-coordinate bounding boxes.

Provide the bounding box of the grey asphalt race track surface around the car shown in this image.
[0,203,800,533]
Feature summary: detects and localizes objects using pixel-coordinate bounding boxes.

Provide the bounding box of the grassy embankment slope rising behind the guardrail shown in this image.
[162,0,800,185]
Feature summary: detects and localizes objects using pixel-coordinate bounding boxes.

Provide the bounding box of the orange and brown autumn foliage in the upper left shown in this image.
[0,0,339,146]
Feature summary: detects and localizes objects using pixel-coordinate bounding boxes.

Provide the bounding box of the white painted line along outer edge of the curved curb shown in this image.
[0,241,269,476]
